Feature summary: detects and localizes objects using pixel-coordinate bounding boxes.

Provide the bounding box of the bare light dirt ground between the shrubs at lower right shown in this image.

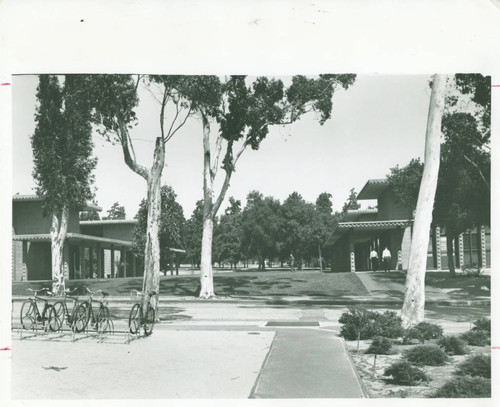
[346,340,491,398]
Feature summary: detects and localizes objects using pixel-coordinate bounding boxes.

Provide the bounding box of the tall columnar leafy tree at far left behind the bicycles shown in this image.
[31,75,97,292]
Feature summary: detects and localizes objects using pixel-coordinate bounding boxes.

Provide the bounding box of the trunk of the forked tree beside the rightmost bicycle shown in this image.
[142,137,165,310]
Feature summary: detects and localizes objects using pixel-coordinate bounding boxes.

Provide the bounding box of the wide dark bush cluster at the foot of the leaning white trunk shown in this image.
[339,308,404,340]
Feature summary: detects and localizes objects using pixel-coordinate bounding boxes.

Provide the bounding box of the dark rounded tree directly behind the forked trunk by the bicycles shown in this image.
[133,185,185,272]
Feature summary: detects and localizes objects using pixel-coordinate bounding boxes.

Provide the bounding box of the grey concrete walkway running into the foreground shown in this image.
[251,329,363,398]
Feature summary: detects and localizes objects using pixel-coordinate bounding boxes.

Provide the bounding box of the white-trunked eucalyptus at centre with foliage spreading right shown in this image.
[195,75,356,298]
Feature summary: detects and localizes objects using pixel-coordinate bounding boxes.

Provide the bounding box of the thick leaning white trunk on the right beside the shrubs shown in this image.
[401,74,447,326]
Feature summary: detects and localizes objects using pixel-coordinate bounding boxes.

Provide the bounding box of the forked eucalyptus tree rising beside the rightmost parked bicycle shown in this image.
[93,75,219,305]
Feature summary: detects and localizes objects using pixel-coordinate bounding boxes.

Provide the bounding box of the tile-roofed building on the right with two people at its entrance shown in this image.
[328,179,491,272]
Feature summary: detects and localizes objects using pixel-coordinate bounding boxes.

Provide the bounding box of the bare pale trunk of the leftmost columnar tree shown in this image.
[50,205,69,294]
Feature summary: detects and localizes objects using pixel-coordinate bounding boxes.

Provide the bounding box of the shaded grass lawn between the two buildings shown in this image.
[12,271,370,298]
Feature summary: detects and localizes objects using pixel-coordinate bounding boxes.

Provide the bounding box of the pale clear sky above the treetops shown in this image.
[12,75,430,218]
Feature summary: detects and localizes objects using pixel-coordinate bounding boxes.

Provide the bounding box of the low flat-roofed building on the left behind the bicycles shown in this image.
[12,195,143,281]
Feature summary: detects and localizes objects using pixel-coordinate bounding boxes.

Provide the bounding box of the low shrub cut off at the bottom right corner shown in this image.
[431,376,491,398]
